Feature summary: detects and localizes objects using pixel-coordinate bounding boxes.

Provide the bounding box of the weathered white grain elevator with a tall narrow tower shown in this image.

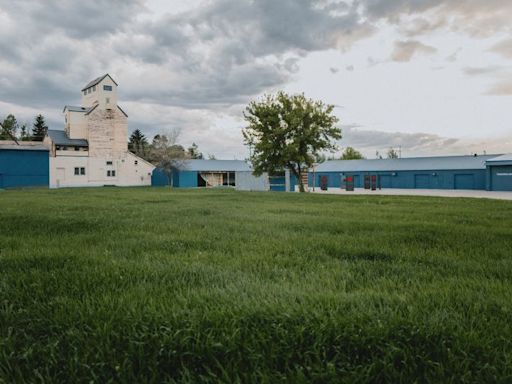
[44,74,155,188]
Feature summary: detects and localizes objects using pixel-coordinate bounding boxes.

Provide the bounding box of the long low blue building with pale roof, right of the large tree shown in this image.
[308,155,512,191]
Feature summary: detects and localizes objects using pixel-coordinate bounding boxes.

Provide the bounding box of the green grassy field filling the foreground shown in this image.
[0,188,512,383]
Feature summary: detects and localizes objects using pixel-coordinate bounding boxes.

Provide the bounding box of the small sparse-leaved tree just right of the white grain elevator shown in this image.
[151,129,188,187]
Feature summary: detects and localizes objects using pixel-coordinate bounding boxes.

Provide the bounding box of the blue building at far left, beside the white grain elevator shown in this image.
[0,142,50,188]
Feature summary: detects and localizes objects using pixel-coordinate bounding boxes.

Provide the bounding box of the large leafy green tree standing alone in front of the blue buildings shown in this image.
[242,92,341,192]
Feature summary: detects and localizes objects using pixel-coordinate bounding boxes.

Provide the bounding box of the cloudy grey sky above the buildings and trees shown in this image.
[0,0,512,159]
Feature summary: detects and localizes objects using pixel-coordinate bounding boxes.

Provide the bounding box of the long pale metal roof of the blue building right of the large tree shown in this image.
[315,155,497,172]
